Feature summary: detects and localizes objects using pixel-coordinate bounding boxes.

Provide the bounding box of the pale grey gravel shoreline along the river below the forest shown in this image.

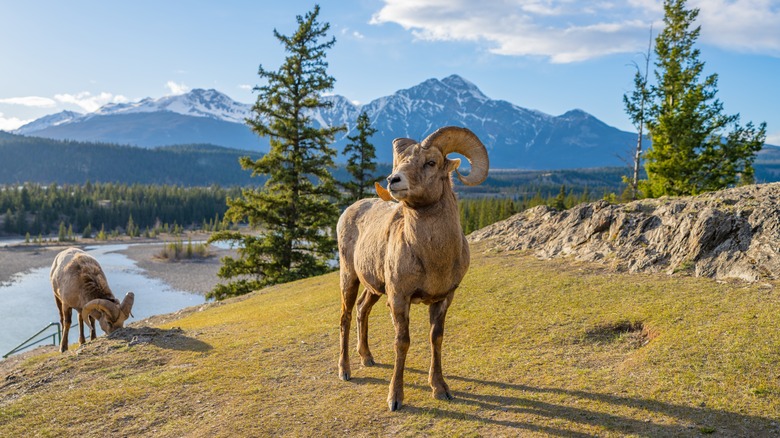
[0,239,236,295]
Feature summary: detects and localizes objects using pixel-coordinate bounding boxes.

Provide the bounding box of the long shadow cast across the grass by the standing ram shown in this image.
[353,364,780,437]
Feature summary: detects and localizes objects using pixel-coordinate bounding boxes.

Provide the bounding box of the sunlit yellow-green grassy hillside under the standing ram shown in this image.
[0,248,780,437]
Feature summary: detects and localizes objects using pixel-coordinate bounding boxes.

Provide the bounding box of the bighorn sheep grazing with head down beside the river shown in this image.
[49,248,135,352]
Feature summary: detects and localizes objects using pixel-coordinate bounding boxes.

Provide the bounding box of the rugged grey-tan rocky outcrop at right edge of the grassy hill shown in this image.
[468,183,780,281]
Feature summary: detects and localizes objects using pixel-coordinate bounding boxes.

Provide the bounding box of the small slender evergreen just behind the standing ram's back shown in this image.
[341,112,379,205]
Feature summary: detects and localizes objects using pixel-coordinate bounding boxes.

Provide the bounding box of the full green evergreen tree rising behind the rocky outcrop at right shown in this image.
[642,0,766,196]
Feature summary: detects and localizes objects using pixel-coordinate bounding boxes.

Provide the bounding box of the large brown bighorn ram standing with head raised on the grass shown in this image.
[337,127,489,411]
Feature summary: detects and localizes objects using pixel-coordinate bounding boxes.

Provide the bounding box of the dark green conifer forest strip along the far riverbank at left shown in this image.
[0,183,240,236]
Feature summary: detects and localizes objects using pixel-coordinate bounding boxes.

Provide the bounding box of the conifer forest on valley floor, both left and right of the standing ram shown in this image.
[0,183,590,238]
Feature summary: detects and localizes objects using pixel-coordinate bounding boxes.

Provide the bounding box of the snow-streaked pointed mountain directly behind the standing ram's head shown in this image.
[326,75,636,169]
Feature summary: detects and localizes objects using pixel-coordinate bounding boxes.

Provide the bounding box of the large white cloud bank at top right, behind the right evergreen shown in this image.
[371,0,780,63]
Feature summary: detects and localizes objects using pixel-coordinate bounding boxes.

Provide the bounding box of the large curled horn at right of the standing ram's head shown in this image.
[420,126,490,186]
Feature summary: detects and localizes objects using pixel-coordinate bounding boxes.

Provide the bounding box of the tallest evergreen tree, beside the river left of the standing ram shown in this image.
[208,6,344,300]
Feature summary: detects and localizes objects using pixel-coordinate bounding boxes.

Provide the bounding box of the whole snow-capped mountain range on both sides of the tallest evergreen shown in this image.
[15,75,636,169]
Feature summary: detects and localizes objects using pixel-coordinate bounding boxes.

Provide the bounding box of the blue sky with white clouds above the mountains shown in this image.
[0,0,780,145]
